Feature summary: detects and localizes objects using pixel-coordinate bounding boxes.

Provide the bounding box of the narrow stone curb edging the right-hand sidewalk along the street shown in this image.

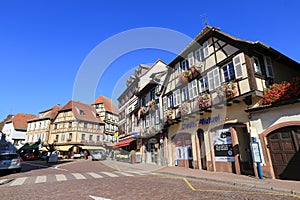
[156,172,300,195]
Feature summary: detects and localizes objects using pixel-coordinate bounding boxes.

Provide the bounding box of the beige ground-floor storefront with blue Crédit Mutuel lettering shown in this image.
[168,102,254,175]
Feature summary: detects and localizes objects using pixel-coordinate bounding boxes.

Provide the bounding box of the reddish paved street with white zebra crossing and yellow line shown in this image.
[0,160,297,200]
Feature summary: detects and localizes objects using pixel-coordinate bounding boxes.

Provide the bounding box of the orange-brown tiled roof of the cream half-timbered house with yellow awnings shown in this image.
[58,100,101,123]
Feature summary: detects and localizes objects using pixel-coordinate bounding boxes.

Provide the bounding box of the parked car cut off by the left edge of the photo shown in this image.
[0,153,23,172]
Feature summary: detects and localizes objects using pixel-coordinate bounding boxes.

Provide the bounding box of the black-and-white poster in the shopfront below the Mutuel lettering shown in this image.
[212,128,234,162]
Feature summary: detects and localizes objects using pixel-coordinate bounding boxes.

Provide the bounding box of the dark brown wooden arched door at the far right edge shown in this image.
[267,128,300,180]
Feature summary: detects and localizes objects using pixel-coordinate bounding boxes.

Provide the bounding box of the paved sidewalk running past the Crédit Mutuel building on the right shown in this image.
[103,160,300,195]
